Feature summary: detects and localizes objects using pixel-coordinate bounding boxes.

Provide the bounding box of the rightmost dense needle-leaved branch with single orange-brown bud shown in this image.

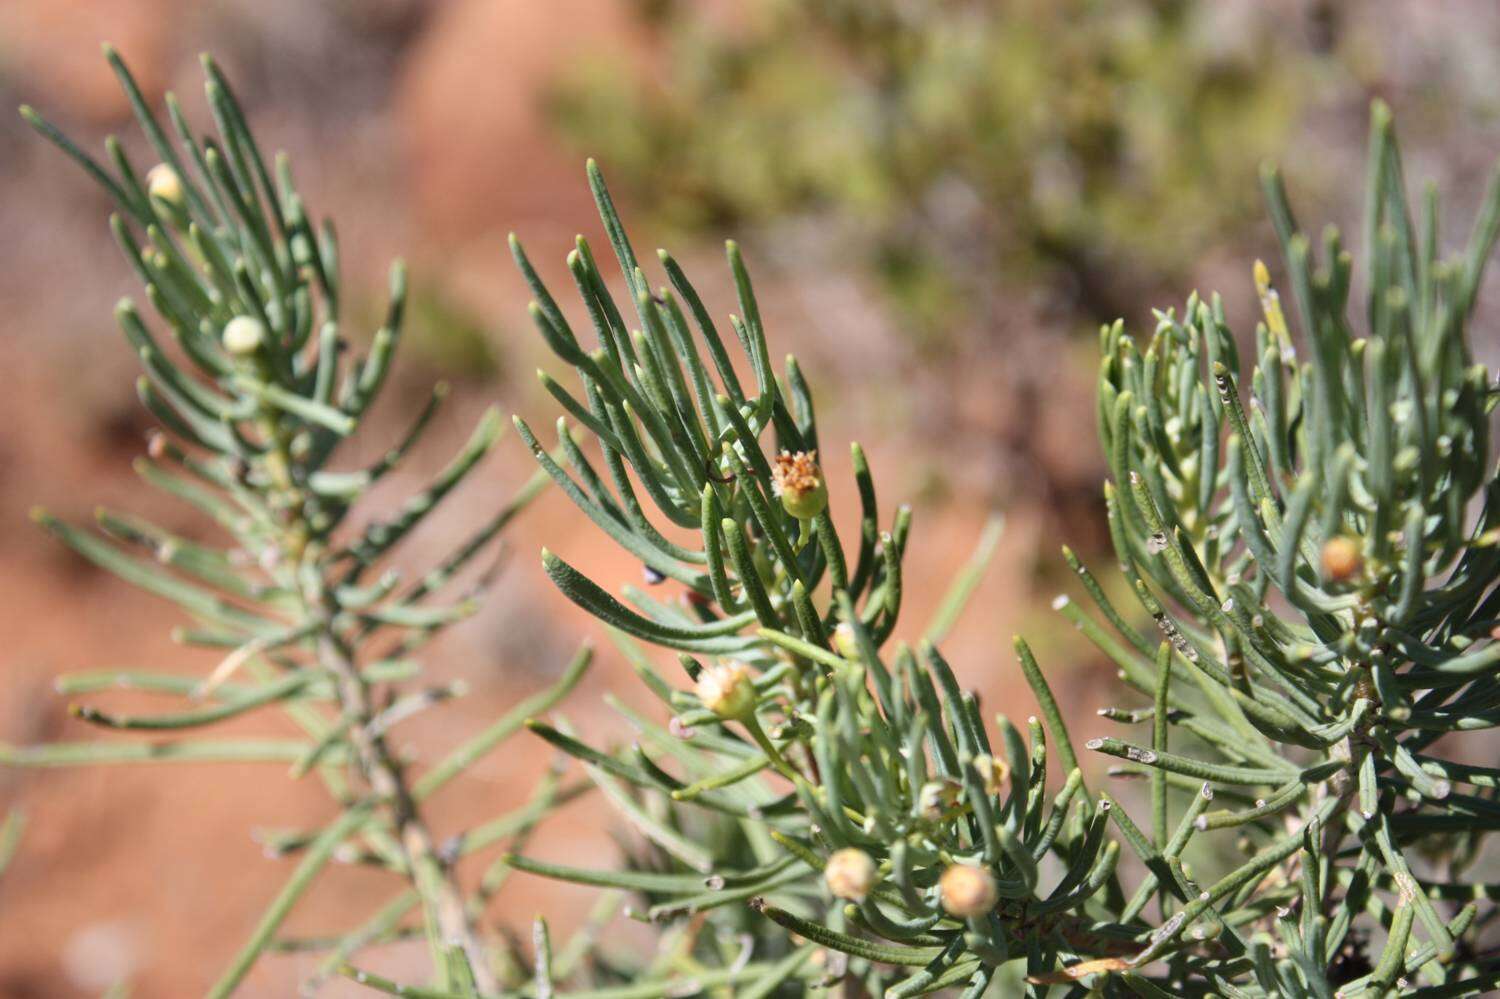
[1064,104,1500,996]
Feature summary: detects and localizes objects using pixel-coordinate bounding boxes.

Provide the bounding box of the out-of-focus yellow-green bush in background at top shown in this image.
[551,0,1329,342]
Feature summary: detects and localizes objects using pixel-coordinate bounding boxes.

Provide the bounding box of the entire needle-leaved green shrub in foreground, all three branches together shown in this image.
[11,39,1500,999]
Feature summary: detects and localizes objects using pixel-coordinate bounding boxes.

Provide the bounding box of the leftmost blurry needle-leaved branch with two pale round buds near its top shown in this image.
[0,50,588,996]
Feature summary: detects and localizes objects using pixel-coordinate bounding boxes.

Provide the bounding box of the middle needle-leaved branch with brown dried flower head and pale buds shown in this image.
[510,165,1139,996]
